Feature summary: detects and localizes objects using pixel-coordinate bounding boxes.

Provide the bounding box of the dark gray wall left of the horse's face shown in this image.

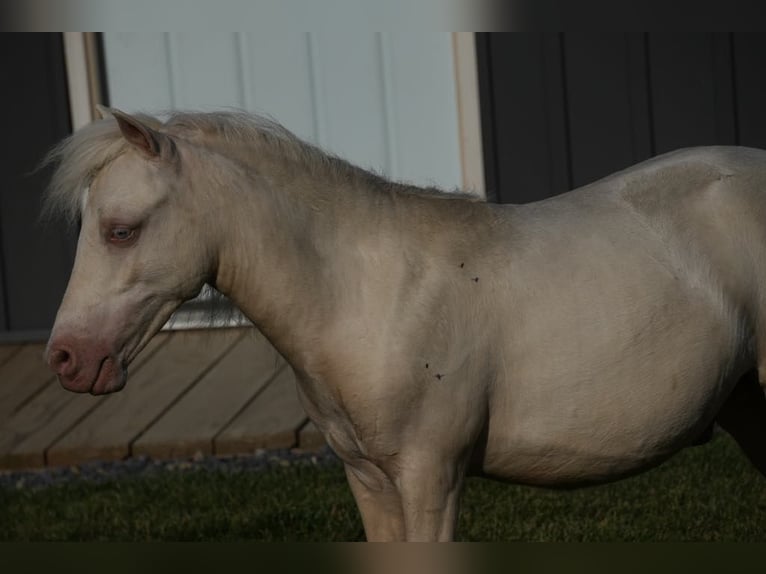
[0,34,74,331]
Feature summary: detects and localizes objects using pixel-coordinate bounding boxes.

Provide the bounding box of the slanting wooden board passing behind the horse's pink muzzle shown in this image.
[0,334,167,468]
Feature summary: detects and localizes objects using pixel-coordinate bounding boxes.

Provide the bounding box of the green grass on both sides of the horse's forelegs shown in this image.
[0,436,766,541]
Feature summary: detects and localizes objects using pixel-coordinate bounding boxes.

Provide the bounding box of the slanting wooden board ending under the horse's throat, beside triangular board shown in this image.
[132,336,285,458]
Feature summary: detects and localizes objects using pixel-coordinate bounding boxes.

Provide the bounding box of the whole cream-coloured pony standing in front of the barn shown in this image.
[47,110,766,540]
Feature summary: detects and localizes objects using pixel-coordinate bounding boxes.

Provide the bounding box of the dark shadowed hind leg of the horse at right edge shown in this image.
[716,370,766,476]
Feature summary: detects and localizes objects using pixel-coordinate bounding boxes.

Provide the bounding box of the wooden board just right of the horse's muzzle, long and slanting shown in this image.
[47,329,244,466]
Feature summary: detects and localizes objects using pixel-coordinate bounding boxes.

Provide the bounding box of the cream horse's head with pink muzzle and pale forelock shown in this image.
[46,110,211,394]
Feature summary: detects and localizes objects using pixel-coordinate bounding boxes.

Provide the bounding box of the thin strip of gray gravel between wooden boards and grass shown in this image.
[0,447,339,489]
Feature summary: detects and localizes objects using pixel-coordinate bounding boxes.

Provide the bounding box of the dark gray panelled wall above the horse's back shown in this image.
[477,33,766,203]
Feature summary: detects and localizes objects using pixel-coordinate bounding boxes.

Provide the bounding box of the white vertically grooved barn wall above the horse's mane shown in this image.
[103,31,462,189]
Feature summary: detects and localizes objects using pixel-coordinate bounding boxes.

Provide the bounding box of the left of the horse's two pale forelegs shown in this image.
[345,464,404,542]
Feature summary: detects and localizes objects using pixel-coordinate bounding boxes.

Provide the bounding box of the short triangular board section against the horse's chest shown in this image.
[214,366,307,454]
